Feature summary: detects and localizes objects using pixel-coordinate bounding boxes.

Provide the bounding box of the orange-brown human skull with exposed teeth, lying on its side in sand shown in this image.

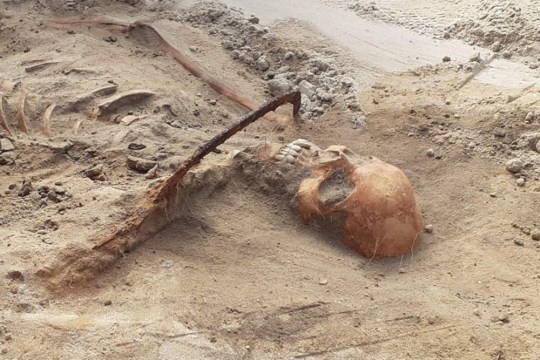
[273,139,423,258]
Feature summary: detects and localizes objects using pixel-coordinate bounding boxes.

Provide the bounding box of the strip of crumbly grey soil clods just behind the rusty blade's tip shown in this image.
[179,2,360,119]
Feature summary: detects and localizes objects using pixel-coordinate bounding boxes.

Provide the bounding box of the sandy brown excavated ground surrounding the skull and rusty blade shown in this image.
[0,1,540,360]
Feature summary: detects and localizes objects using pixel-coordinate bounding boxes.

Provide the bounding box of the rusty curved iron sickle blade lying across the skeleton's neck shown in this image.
[37,92,301,290]
